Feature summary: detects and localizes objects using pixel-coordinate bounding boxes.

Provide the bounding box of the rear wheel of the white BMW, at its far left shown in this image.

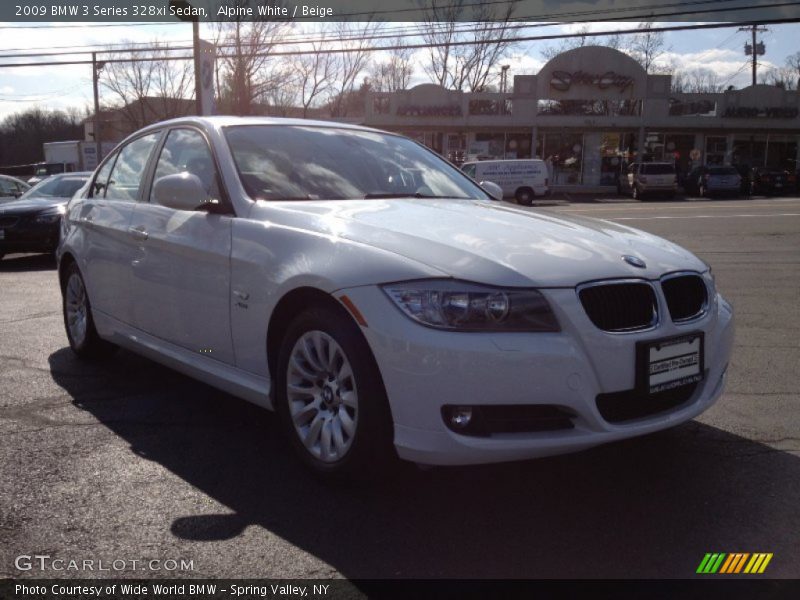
[61,262,116,359]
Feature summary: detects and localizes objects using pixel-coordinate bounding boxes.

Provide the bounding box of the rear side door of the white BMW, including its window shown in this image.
[77,132,161,324]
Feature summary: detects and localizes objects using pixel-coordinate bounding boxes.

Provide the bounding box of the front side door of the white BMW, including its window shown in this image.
[130,128,234,364]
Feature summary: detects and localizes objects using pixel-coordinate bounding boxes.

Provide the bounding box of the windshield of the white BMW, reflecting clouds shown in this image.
[225,125,488,200]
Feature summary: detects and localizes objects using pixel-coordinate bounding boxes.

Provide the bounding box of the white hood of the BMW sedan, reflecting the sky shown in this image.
[264,199,707,287]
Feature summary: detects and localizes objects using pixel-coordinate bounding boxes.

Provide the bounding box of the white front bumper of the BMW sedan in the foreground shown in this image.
[337,278,733,465]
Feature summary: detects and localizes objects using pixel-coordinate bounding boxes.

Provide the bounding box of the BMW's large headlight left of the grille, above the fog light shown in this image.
[382,279,560,331]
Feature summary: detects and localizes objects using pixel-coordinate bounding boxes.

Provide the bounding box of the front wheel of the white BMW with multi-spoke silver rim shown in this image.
[275,306,396,480]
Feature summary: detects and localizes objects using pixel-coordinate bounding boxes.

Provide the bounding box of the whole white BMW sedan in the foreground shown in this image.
[58,117,733,477]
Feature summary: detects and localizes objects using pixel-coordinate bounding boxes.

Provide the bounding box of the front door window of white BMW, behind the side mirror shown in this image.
[150,129,220,202]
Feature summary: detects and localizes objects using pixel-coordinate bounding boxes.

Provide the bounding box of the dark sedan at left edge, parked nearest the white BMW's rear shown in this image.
[0,172,91,258]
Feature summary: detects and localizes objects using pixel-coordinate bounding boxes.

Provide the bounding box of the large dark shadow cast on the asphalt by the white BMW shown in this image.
[49,348,800,578]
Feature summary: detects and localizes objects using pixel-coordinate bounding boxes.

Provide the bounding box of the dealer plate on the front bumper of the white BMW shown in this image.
[639,333,703,394]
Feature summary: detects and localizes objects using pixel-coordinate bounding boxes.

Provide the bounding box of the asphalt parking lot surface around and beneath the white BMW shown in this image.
[0,198,800,578]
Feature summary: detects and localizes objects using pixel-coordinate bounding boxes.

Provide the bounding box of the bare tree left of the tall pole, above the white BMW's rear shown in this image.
[100,41,194,129]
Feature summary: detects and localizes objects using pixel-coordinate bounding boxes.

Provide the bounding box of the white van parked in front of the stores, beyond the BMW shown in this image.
[461,158,550,206]
